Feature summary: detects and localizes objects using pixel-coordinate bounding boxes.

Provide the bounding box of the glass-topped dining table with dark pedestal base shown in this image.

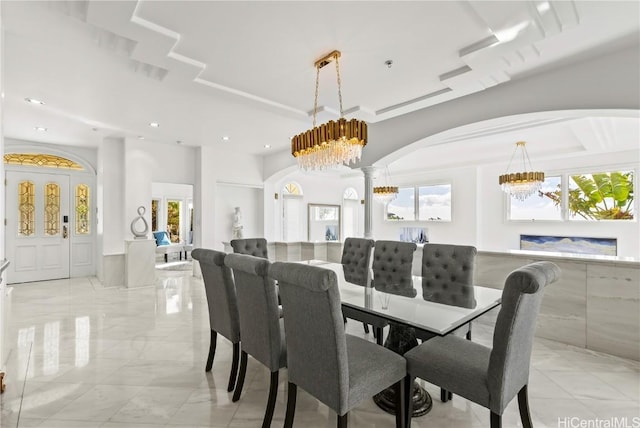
[300,260,502,417]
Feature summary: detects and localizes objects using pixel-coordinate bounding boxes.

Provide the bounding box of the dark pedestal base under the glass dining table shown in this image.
[373,322,433,417]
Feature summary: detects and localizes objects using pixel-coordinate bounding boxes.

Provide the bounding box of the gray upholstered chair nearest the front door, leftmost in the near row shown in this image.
[191,248,240,392]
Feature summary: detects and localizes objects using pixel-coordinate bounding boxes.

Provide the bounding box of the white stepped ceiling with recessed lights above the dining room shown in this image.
[1,1,640,163]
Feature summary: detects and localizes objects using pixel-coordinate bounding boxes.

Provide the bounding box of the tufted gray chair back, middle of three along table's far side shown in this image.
[372,241,417,290]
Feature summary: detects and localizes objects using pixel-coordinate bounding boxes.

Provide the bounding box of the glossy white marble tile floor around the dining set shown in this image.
[0,264,640,428]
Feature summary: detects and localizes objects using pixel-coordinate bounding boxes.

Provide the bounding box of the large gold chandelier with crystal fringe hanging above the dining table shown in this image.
[291,51,367,170]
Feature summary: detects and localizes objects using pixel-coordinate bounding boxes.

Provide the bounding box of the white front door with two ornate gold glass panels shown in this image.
[5,171,71,283]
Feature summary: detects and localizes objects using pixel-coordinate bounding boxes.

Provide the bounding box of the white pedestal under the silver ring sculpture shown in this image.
[125,239,156,288]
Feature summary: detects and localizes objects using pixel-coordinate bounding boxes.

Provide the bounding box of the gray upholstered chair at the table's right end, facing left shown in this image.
[405,262,560,428]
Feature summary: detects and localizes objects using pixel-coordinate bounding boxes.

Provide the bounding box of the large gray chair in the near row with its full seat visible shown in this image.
[269,262,406,428]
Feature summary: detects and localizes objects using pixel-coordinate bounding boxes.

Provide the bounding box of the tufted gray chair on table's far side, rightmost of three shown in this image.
[416,243,478,402]
